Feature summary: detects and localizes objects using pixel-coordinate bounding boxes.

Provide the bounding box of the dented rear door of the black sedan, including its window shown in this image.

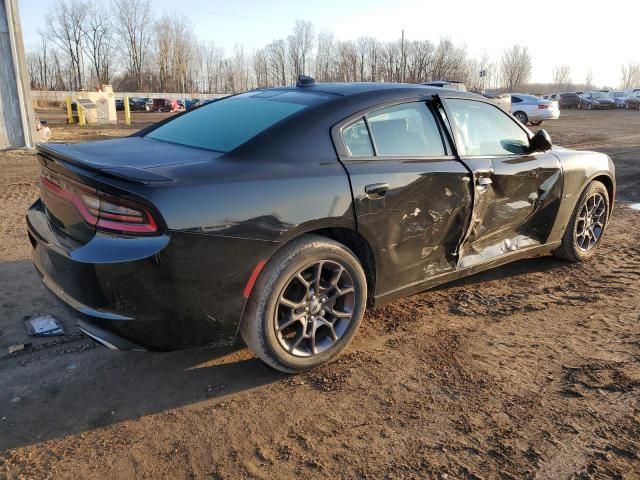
[334,101,472,295]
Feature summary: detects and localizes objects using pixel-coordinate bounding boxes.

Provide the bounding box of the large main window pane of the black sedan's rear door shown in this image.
[367,103,444,156]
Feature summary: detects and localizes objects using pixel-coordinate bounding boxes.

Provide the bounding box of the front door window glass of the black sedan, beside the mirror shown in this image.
[447,99,529,156]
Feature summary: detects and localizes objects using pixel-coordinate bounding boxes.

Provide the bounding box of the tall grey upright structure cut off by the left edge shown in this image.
[0,0,36,150]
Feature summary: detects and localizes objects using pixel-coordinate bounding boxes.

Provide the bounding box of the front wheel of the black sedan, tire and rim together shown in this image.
[554,181,609,262]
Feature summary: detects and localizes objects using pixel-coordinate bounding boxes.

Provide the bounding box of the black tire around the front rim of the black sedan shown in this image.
[553,180,610,262]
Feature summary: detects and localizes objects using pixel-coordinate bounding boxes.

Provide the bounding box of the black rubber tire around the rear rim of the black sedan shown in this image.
[240,235,367,373]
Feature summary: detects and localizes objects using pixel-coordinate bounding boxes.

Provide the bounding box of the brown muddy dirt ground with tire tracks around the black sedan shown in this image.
[0,111,640,480]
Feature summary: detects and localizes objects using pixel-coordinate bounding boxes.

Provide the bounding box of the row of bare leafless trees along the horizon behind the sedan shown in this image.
[27,0,635,93]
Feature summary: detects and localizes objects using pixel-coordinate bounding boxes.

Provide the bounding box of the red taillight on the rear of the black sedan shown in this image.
[40,173,158,234]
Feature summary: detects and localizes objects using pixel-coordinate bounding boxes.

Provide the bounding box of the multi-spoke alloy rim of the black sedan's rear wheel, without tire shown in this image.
[274,260,356,357]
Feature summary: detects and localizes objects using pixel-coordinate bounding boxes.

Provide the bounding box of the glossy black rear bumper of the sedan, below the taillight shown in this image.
[27,200,259,350]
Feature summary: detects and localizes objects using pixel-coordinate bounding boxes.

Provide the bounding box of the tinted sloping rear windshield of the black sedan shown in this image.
[146,90,326,152]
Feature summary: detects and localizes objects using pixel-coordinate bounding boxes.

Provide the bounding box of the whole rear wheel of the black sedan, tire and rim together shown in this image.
[240,235,367,373]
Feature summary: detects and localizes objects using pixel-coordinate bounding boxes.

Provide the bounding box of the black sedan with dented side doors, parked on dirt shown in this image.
[27,78,615,372]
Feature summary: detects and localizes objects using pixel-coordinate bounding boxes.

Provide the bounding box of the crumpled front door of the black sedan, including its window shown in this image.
[444,98,562,268]
